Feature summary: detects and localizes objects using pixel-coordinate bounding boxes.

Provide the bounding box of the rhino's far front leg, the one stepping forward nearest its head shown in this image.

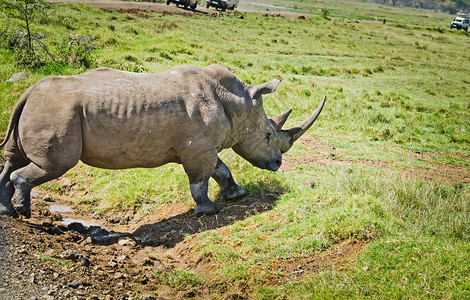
[212,158,245,199]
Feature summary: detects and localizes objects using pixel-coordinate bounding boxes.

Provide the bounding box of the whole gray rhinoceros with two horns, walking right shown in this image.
[0,64,325,217]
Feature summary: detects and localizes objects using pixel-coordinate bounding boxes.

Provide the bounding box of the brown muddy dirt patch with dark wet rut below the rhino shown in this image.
[0,192,276,299]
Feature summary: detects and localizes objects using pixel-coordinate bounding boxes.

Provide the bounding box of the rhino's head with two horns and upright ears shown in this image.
[232,79,326,171]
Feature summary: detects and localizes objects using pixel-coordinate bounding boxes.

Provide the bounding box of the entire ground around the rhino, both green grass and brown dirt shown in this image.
[0,1,470,299]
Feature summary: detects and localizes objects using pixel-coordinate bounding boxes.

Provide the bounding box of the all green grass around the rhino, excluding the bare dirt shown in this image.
[0,1,470,299]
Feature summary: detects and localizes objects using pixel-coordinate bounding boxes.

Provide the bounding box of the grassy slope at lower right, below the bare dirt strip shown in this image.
[193,166,470,299]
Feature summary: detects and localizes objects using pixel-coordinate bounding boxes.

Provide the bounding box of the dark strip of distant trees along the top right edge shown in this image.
[369,0,470,14]
